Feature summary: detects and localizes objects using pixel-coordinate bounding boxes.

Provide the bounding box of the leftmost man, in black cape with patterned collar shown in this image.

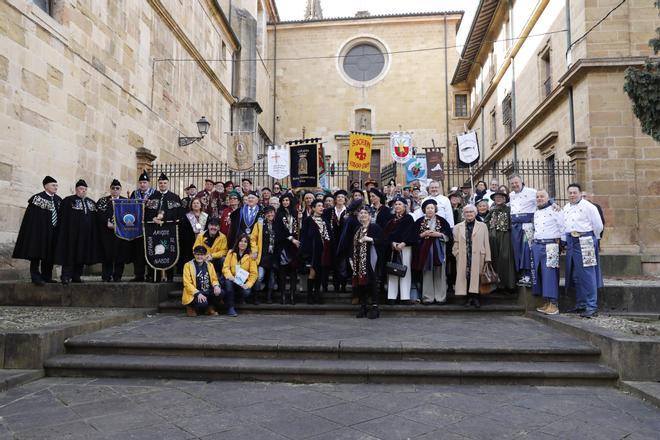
[12,176,62,286]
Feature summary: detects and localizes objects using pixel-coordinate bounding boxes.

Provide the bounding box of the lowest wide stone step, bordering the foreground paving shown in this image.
[45,354,618,386]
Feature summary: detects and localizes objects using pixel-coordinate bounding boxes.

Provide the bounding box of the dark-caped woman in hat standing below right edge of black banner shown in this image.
[300,200,333,304]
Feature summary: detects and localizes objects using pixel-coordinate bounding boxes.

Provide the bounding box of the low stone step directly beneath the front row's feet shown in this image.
[158,299,525,316]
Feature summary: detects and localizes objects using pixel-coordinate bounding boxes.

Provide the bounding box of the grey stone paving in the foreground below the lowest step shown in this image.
[0,378,660,440]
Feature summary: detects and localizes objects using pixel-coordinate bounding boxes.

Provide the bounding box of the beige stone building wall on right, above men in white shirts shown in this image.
[459,0,660,269]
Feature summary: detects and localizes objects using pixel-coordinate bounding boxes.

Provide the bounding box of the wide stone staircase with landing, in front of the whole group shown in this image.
[45,312,618,386]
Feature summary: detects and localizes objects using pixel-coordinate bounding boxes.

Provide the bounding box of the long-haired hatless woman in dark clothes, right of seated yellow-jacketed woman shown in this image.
[274,193,300,304]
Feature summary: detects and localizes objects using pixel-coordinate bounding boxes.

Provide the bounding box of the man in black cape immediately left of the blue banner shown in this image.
[96,179,133,282]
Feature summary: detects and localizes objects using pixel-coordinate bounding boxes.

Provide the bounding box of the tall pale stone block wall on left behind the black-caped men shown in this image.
[0,0,241,278]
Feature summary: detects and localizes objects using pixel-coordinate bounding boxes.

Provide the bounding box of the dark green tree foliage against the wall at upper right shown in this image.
[623,0,660,142]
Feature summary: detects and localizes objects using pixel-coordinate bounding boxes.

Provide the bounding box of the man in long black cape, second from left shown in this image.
[55,179,100,285]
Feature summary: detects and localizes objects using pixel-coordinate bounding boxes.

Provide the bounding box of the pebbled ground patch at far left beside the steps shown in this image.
[0,307,150,333]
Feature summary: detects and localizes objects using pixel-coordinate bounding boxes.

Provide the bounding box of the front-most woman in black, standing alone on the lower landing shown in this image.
[351,205,383,319]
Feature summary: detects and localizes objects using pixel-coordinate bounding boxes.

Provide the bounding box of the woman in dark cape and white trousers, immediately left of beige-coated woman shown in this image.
[412,199,452,304]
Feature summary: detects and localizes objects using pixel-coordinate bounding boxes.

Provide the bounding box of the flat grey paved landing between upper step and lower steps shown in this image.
[65,315,590,349]
